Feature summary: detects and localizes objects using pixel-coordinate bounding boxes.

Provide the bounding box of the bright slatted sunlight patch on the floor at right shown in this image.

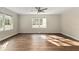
[48,35,79,46]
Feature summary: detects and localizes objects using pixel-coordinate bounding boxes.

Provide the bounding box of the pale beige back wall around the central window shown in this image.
[19,15,60,33]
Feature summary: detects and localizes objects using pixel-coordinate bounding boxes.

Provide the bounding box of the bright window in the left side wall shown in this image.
[0,14,13,31]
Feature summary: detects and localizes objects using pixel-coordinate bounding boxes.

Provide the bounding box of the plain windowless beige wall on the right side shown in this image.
[61,7,79,39]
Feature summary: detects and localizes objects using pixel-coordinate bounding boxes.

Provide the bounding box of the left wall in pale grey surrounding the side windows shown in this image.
[0,7,18,40]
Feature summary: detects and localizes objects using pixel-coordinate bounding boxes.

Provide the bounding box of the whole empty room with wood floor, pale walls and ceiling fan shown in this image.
[0,7,79,51]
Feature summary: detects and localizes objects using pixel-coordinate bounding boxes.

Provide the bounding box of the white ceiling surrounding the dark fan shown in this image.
[6,7,70,14]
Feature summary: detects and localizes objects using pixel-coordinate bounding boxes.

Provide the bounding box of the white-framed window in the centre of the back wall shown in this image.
[32,18,47,28]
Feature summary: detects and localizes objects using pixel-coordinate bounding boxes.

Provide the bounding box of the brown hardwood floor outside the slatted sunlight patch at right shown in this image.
[0,34,79,51]
